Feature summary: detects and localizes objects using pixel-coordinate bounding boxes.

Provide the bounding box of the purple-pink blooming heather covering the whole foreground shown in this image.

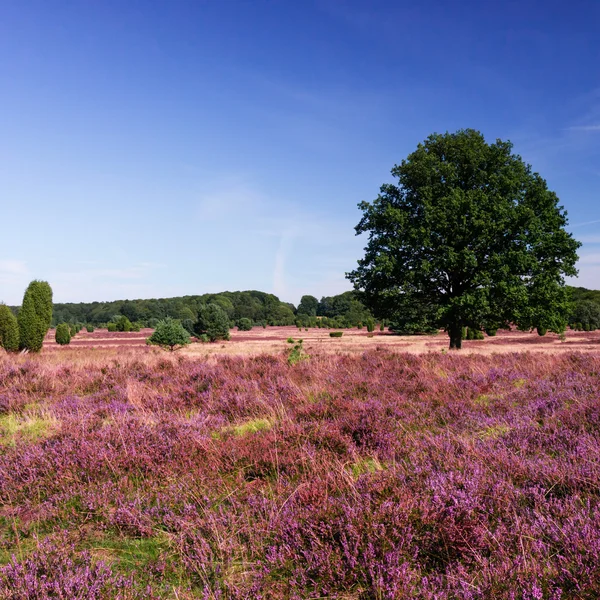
[0,346,600,600]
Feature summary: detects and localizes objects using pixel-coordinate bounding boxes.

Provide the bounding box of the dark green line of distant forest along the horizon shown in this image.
[5,286,600,328]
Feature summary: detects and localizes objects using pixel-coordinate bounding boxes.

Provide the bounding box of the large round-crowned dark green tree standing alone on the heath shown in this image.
[347,129,580,348]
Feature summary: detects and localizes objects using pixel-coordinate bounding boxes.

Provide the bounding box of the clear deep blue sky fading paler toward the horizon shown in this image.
[0,0,600,304]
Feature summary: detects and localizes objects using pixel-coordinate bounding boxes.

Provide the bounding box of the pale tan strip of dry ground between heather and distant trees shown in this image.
[44,327,600,356]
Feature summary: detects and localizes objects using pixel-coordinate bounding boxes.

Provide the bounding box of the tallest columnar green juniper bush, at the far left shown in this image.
[17,280,52,352]
